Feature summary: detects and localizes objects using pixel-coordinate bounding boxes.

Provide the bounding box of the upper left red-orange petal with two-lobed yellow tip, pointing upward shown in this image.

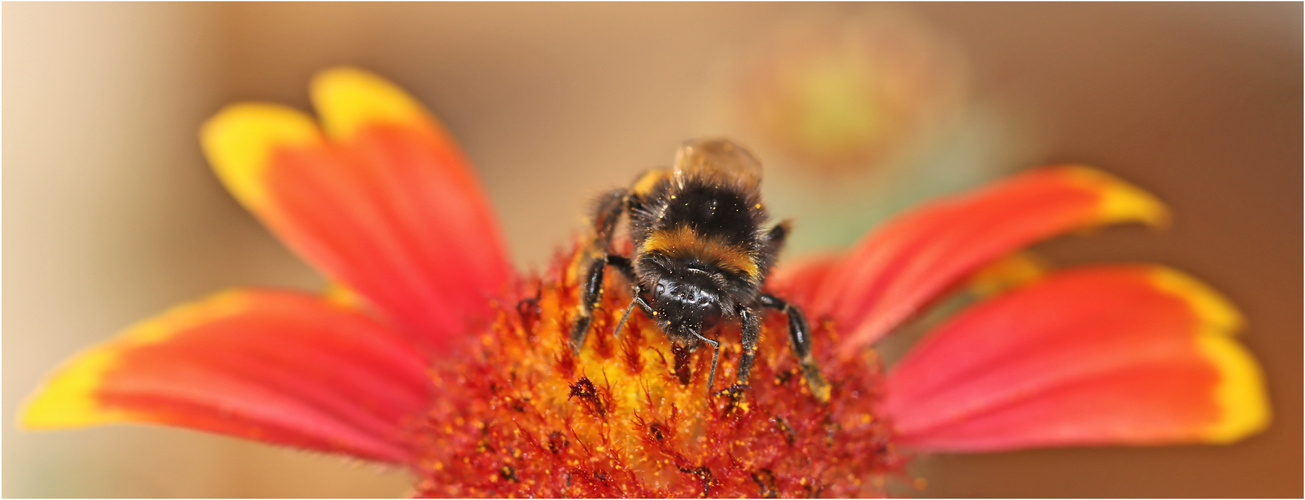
[204,68,512,351]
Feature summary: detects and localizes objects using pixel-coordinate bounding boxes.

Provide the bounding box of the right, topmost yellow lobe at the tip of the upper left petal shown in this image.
[312,67,432,138]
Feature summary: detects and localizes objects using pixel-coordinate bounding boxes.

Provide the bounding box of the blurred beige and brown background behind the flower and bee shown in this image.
[0,3,1302,497]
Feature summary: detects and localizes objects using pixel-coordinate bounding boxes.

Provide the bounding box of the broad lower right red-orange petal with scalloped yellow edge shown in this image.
[883,266,1268,452]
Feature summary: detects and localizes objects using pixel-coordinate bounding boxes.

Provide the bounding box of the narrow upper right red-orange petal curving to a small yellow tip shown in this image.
[804,166,1165,355]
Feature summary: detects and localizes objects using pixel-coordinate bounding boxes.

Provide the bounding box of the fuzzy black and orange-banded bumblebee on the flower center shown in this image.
[570,138,830,402]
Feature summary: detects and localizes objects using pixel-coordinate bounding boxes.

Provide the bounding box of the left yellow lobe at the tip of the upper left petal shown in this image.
[200,103,321,209]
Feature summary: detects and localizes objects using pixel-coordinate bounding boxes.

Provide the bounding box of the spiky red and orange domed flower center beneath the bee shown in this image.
[415,250,904,497]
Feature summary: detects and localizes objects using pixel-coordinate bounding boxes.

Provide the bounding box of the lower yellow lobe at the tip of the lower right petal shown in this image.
[1197,333,1270,444]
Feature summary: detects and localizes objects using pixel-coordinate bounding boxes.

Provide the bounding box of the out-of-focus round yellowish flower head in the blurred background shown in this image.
[728,8,970,179]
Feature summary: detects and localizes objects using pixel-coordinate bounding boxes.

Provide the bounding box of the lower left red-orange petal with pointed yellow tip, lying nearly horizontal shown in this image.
[21,290,433,463]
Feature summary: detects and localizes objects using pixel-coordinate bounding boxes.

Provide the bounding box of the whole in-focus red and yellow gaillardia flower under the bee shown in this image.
[21,68,1268,497]
